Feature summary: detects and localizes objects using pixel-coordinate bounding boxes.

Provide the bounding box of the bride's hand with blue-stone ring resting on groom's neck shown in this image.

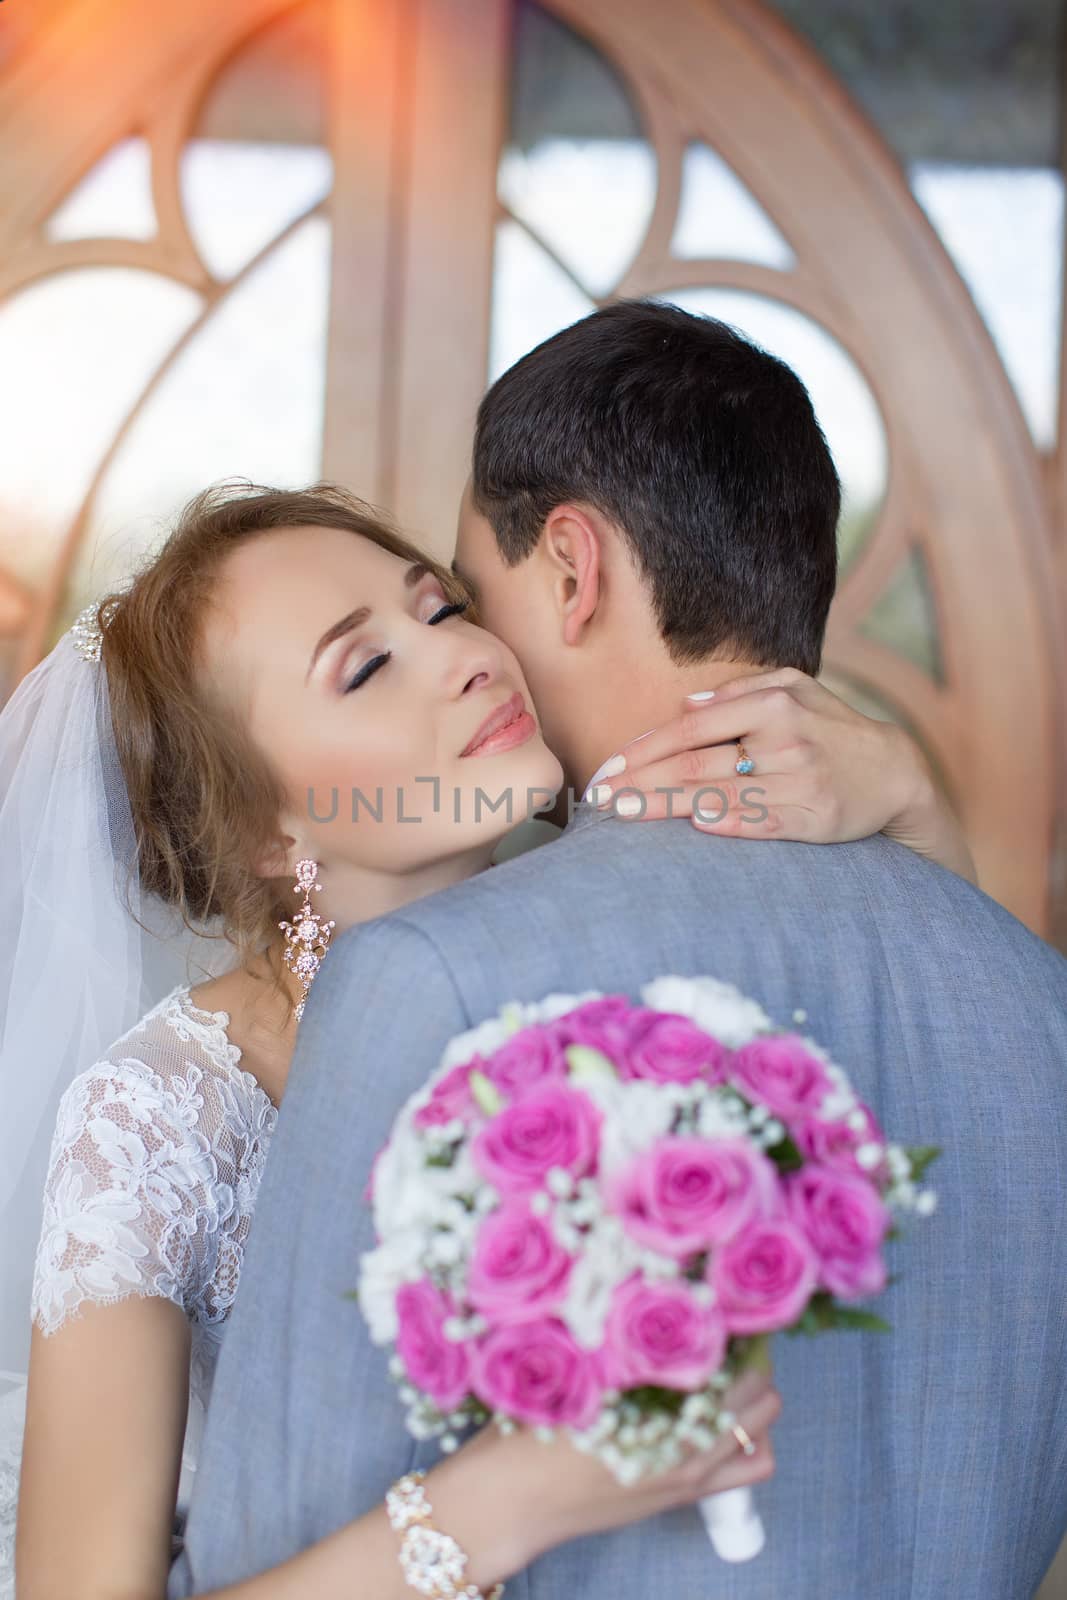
[595,667,977,883]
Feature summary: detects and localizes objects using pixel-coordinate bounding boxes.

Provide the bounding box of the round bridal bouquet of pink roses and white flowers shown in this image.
[358,978,937,1558]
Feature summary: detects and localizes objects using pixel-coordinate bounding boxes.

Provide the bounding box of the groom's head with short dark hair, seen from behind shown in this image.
[456,301,840,787]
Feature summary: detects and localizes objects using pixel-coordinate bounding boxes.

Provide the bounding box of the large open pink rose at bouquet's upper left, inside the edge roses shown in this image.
[470,1083,600,1194]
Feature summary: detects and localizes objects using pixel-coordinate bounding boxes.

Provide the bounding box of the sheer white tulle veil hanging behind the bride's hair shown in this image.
[0,608,235,1394]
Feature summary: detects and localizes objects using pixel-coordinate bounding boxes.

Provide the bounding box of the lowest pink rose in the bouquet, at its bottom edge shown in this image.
[474,1317,601,1427]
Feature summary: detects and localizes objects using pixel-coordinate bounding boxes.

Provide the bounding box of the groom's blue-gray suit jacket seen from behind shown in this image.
[170,808,1067,1600]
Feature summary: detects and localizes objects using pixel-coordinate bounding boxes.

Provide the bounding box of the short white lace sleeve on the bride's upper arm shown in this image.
[32,1056,225,1334]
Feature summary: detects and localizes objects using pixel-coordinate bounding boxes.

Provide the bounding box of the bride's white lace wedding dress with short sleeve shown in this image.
[0,986,278,1600]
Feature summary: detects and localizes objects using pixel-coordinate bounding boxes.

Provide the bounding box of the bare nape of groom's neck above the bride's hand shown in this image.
[553,661,760,795]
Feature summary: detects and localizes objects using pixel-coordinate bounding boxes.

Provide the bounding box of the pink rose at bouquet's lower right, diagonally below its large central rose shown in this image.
[707,1218,819,1333]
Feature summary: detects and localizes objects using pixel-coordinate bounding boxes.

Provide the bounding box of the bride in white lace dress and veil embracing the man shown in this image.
[0,486,969,1600]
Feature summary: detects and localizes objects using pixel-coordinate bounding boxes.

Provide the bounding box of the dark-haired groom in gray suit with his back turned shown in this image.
[170,304,1067,1600]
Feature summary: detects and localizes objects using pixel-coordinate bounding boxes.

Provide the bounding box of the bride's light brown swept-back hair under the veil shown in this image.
[99,483,466,1004]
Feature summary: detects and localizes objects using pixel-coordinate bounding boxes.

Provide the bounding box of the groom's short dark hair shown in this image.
[472,301,841,675]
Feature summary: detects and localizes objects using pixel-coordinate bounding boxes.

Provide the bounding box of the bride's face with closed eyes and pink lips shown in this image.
[205,526,561,920]
